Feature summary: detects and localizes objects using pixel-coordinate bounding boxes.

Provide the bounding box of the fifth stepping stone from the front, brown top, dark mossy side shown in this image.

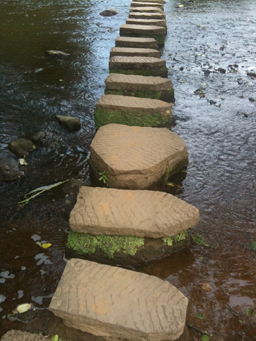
[105,73,174,103]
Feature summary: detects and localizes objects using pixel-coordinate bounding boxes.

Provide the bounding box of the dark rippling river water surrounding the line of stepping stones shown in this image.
[0,0,256,341]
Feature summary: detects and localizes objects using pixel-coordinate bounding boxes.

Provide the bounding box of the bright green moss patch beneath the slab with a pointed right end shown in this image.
[67,231,144,258]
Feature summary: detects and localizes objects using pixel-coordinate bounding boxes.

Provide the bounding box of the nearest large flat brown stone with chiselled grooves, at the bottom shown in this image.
[49,259,188,341]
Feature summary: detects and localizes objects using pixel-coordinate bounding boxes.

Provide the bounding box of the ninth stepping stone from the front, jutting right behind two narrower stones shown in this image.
[120,24,167,45]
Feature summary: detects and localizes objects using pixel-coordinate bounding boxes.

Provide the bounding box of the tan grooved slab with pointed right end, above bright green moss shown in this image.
[69,187,199,238]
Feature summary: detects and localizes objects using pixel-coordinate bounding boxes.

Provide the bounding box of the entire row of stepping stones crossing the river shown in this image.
[50,0,199,341]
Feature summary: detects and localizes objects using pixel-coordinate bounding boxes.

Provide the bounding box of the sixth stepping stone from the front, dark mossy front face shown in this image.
[109,56,168,78]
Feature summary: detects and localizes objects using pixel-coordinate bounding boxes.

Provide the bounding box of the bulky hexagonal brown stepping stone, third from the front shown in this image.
[89,124,188,189]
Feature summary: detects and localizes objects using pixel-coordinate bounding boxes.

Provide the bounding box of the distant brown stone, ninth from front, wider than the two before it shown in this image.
[120,24,167,38]
